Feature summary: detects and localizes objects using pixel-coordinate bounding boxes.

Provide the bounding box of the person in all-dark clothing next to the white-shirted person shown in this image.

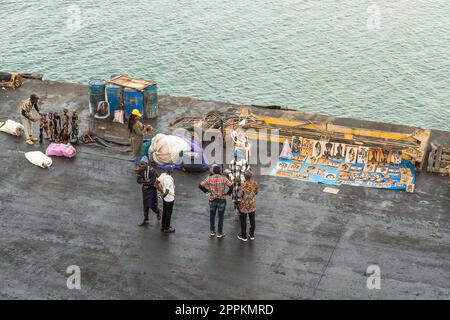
[137,156,161,227]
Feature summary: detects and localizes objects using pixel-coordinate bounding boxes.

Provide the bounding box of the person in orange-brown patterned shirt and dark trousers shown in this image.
[237,171,259,242]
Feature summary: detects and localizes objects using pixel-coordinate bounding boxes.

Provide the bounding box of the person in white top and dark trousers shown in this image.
[157,166,175,233]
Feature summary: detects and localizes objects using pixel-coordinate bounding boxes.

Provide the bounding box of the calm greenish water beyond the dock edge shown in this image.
[0,0,450,130]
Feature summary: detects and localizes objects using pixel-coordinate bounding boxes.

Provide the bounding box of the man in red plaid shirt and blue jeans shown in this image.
[199,165,233,239]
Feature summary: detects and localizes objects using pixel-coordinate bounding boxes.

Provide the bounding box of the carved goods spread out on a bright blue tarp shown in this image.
[271,137,415,192]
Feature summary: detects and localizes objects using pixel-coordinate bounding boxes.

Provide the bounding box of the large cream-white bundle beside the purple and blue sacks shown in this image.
[149,133,191,164]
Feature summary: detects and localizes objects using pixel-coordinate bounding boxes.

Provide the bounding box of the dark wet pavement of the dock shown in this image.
[0,81,450,299]
